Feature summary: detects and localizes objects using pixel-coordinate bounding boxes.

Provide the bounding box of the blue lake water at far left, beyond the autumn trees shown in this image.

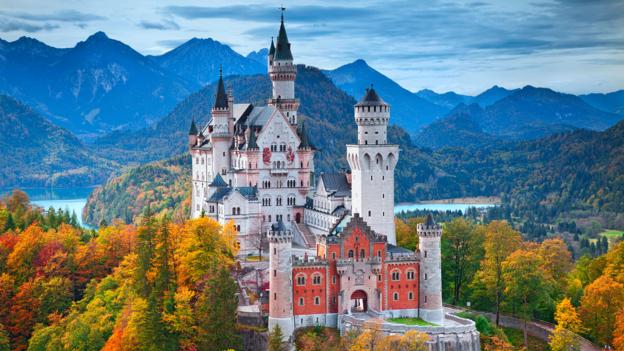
[0,187,93,227]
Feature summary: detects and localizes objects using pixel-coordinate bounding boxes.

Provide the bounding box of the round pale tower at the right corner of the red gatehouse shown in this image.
[416,214,444,324]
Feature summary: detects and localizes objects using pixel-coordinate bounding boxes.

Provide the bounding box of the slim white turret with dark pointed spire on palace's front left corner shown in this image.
[209,69,234,180]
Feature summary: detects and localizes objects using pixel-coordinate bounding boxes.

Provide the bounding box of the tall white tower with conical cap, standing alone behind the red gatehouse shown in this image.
[347,86,399,245]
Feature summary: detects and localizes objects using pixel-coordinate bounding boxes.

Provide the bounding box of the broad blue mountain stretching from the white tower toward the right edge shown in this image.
[414,86,620,149]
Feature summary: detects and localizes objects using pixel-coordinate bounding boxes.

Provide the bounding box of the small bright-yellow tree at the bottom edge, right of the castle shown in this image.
[549,297,584,351]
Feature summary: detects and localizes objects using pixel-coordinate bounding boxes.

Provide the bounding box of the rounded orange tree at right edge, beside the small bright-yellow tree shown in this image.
[581,274,624,344]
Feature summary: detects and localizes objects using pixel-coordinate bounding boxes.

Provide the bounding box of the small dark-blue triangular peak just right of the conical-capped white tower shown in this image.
[414,103,497,149]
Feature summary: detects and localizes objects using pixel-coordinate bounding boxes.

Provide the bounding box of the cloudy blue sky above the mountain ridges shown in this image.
[0,0,624,95]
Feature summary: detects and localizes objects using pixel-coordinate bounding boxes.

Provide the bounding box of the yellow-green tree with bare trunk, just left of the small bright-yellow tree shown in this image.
[503,249,550,349]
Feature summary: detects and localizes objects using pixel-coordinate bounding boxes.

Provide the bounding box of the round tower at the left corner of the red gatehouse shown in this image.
[267,221,295,340]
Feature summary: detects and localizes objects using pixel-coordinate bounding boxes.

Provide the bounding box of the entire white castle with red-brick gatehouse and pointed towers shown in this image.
[189,14,478,350]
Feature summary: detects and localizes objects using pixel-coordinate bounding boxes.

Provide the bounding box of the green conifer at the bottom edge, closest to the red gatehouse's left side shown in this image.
[195,268,240,350]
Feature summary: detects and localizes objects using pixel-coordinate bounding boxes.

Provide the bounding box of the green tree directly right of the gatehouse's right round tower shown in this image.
[442,217,484,305]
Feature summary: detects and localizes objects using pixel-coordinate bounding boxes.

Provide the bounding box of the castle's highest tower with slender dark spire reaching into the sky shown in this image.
[269,8,299,125]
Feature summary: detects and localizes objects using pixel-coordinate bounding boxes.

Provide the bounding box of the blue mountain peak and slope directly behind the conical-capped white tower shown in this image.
[324,59,449,133]
